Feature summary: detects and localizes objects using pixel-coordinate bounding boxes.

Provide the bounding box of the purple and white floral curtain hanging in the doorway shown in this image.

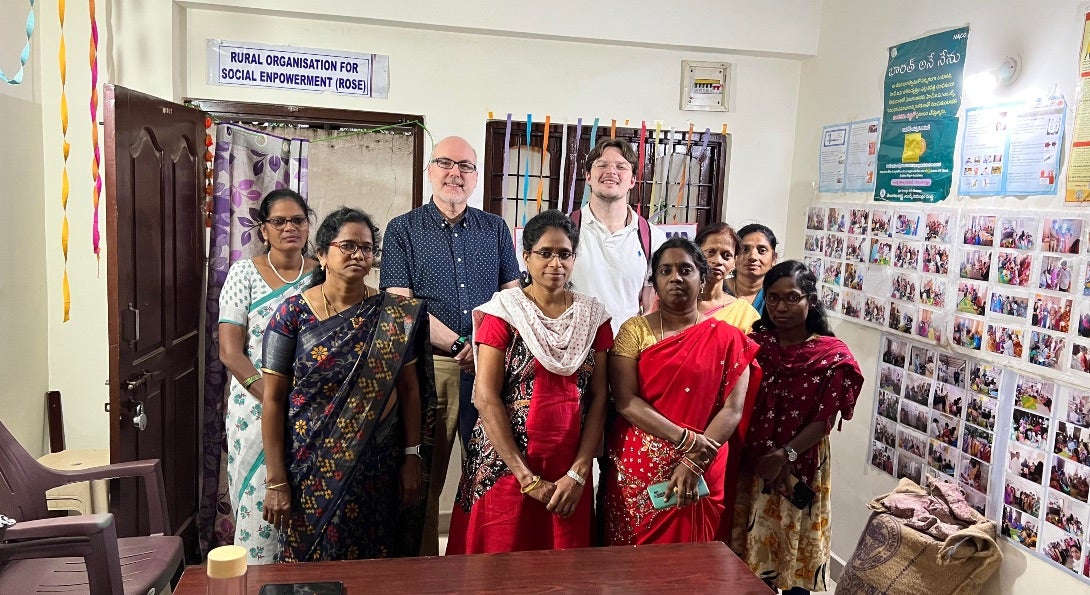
[197,124,310,553]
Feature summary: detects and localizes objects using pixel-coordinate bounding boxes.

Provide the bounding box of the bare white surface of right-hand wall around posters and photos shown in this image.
[777,0,1088,593]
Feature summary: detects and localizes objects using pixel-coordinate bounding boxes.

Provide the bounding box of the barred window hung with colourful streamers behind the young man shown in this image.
[483,120,730,229]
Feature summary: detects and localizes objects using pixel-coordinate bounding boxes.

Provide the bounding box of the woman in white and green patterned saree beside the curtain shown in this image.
[219,189,317,564]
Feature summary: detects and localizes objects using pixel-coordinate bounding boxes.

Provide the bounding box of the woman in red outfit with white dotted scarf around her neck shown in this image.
[447,210,613,554]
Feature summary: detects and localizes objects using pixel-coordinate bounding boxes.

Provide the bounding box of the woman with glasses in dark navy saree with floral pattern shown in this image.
[263,207,435,562]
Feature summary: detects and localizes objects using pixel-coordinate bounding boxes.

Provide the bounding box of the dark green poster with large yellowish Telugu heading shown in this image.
[874,27,969,203]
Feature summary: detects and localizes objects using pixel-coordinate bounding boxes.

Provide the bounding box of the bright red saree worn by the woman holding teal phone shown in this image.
[602,318,761,545]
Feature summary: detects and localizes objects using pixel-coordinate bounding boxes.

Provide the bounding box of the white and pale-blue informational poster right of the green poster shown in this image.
[958,97,1066,196]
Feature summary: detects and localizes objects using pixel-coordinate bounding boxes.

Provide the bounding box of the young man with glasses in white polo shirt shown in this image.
[571,138,666,335]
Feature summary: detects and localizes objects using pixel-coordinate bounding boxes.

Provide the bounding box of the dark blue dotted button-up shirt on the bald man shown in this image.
[378,201,519,337]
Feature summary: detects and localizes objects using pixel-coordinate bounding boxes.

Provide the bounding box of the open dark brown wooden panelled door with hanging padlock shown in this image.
[104,85,205,555]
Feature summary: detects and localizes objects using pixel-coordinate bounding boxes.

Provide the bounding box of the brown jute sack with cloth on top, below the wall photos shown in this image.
[836,478,1003,595]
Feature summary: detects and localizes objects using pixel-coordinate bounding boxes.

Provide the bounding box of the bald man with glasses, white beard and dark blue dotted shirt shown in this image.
[379,136,519,556]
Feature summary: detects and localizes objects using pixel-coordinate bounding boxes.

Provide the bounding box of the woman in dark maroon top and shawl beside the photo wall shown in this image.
[731,260,863,594]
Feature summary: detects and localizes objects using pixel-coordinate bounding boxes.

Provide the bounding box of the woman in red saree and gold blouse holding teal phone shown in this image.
[602,238,761,545]
